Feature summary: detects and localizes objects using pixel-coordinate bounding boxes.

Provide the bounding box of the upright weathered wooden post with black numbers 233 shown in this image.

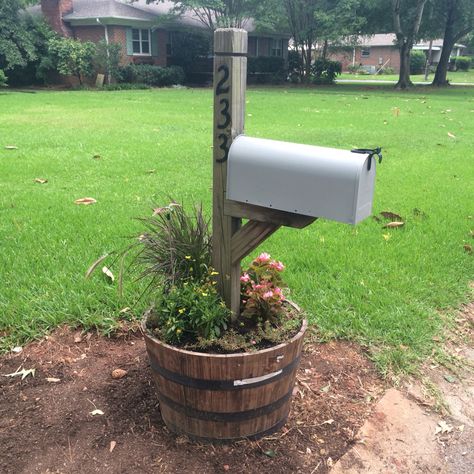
[212,28,247,321]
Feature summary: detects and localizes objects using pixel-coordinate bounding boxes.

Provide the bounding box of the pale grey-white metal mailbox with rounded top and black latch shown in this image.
[226,135,375,224]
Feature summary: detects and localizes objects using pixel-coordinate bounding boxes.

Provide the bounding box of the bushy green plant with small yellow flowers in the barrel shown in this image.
[147,277,230,344]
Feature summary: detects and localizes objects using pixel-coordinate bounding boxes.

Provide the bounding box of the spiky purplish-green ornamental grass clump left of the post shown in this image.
[134,202,211,289]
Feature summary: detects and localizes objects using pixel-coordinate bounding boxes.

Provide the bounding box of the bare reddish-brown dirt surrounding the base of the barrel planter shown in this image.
[0,329,382,474]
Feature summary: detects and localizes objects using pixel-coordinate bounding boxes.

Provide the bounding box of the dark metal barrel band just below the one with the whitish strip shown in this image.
[158,387,293,423]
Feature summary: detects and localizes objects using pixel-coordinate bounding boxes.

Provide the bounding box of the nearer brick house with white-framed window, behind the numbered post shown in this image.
[33,0,289,66]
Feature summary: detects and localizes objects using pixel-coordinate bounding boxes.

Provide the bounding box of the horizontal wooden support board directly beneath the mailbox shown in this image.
[224,199,317,229]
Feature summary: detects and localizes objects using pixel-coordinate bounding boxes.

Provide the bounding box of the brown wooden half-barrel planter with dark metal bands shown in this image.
[143,321,307,442]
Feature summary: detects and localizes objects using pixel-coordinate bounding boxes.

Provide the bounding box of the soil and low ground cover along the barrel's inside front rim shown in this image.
[146,304,304,354]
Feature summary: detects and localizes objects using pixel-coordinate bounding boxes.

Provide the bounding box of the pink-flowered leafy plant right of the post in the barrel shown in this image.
[240,253,286,325]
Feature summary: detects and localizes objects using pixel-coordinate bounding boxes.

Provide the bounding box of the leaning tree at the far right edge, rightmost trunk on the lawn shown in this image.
[432,0,474,87]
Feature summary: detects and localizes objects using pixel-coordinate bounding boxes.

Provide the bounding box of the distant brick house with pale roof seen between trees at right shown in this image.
[332,33,465,73]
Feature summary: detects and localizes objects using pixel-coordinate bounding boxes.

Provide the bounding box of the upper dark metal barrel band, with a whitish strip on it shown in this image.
[150,356,300,390]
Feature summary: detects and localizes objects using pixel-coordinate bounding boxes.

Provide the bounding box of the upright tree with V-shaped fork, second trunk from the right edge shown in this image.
[391,0,427,89]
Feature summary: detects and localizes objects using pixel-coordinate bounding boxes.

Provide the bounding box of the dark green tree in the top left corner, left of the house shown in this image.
[0,0,36,71]
